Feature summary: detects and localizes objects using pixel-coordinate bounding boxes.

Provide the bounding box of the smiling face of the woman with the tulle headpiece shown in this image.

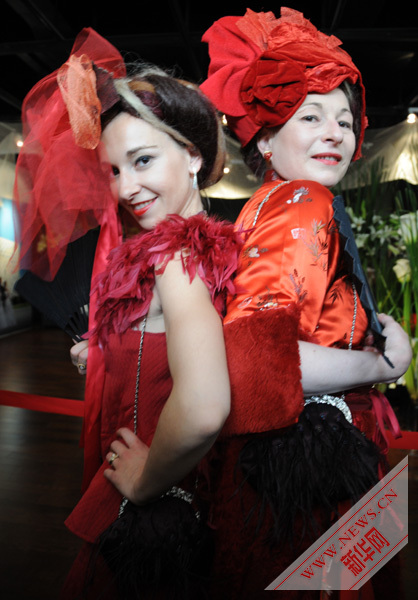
[102,113,202,229]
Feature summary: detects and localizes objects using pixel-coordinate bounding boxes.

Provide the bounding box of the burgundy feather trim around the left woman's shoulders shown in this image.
[88,214,243,345]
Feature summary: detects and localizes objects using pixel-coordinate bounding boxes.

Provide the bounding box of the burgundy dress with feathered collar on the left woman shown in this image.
[62,215,242,600]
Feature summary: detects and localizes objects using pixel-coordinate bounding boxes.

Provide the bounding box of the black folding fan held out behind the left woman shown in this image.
[15,228,99,341]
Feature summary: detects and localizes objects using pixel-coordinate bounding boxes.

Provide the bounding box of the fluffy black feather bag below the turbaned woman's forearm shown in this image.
[237,403,382,547]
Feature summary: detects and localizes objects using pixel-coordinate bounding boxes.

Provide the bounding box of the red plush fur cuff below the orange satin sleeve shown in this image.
[221,305,304,437]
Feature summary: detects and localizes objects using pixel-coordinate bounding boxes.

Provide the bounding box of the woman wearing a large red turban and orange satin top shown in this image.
[201,8,410,600]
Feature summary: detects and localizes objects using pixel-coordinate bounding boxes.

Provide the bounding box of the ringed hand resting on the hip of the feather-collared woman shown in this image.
[104,427,149,504]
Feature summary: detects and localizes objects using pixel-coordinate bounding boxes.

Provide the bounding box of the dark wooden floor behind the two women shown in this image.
[0,327,418,600]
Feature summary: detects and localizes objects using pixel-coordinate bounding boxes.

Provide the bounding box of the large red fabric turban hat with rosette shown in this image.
[200,7,367,158]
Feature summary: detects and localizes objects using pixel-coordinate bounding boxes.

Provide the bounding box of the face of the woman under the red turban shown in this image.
[258,88,356,187]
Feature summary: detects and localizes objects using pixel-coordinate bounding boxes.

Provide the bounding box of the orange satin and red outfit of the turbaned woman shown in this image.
[206,179,402,600]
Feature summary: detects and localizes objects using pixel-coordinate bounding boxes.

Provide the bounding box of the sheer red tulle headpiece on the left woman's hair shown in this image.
[14,28,126,280]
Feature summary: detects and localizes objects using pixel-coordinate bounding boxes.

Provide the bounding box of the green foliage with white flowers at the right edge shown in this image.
[342,162,418,401]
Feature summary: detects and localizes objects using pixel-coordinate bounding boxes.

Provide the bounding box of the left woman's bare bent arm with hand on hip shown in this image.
[105,261,230,504]
